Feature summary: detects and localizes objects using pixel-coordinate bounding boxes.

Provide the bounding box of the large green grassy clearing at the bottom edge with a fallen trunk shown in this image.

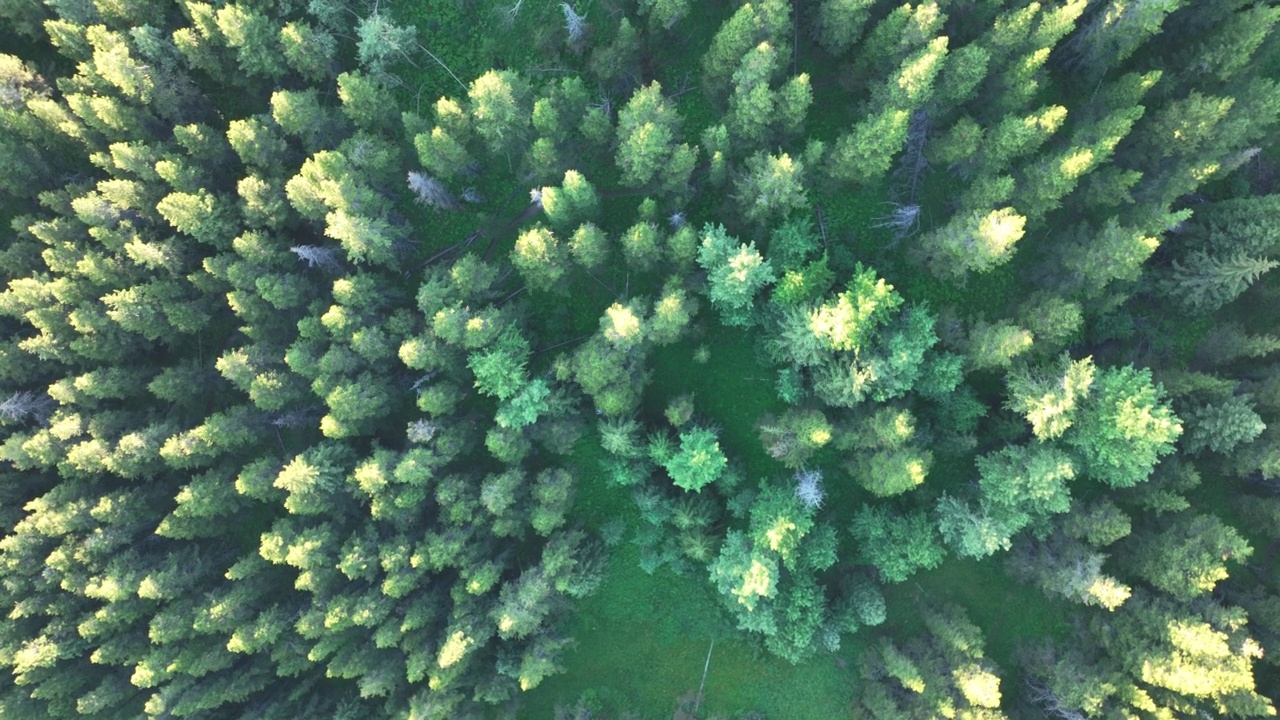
[520,538,854,720]
